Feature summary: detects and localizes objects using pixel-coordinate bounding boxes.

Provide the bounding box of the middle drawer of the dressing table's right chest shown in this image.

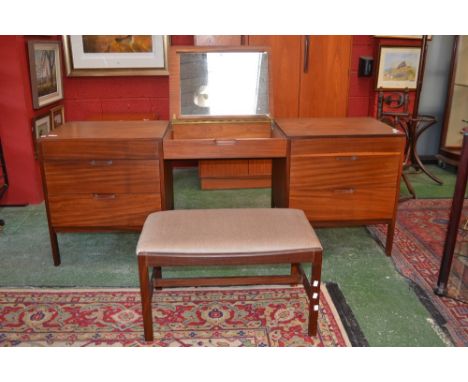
[290,154,401,192]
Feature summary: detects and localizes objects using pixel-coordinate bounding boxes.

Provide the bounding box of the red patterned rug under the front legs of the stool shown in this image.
[0,285,358,346]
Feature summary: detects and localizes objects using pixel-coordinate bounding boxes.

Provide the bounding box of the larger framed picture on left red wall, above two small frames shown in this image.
[28,41,63,109]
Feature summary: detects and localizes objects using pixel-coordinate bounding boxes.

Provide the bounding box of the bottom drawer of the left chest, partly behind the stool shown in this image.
[49,194,161,228]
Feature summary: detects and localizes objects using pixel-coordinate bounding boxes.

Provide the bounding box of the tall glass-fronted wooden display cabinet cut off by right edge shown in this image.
[438,36,468,165]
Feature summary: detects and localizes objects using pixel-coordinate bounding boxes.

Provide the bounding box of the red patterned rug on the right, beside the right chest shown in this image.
[369,199,468,346]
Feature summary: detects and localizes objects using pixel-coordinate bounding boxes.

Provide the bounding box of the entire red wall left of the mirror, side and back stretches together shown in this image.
[0,36,193,205]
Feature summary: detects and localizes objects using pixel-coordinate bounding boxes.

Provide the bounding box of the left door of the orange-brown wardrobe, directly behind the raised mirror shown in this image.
[247,36,302,118]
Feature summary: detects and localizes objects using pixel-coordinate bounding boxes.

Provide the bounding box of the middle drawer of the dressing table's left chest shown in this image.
[44,159,160,195]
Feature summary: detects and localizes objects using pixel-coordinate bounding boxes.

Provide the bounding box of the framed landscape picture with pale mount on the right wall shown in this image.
[376,46,421,90]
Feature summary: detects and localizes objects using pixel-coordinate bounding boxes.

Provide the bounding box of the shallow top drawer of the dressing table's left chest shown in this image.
[41,138,160,160]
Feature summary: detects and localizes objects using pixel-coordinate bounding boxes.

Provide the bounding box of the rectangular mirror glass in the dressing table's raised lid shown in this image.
[180,52,270,116]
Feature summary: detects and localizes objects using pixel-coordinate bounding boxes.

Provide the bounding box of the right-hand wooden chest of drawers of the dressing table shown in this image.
[277,118,405,254]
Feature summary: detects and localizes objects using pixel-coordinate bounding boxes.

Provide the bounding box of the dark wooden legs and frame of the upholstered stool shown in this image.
[138,248,322,341]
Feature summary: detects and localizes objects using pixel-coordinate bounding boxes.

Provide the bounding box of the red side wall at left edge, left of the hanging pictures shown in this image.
[0,36,61,205]
